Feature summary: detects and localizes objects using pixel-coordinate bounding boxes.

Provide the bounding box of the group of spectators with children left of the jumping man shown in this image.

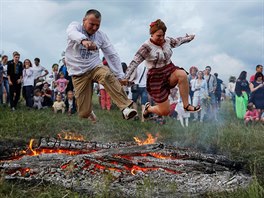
[0,51,77,115]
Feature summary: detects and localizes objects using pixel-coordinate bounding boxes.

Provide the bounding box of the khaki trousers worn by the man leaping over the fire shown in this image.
[72,65,133,118]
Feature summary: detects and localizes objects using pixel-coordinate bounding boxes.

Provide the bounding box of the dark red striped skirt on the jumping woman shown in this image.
[147,63,187,103]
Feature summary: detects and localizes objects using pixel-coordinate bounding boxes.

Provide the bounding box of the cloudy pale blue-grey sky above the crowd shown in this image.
[0,0,264,83]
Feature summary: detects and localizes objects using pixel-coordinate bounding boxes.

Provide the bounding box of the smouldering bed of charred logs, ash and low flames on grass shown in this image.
[0,135,251,197]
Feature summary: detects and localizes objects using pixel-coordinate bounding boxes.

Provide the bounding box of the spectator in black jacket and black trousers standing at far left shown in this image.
[7,51,23,111]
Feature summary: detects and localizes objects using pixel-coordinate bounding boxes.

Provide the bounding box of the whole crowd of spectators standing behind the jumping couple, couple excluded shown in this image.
[0,52,264,127]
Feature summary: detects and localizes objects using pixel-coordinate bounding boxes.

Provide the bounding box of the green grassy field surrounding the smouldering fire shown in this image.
[0,97,264,198]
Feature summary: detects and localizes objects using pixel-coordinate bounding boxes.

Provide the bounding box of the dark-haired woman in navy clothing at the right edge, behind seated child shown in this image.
[249,72,264,112]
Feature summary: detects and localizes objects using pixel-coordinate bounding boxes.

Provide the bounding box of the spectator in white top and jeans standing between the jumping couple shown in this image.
[131,64,148,122]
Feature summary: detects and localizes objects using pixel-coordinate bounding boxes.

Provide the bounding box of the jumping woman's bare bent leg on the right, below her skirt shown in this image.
[169,69,198,111]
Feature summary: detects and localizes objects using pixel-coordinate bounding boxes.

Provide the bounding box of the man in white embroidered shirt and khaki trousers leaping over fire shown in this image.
[65,9,137,122]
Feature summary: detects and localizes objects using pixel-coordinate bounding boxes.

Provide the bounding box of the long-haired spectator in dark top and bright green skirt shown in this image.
[235,71,250,119]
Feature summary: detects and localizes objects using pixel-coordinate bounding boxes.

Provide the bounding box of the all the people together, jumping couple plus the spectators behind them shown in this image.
[0,9,264,127]
